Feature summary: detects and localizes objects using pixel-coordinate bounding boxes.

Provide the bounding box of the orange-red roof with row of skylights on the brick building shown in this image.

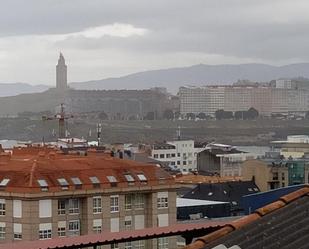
[0,148,175,193]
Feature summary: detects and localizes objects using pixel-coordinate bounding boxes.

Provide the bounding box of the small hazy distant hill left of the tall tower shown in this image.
[0,83,49,97]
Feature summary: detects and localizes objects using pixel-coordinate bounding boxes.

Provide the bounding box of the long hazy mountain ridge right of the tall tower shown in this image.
[70,63,309,93]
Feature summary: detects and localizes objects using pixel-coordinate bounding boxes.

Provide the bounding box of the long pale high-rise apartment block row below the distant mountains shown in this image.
[179,83,309,116]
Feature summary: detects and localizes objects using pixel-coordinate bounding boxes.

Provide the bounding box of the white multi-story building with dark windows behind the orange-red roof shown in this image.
[151,140,204,173]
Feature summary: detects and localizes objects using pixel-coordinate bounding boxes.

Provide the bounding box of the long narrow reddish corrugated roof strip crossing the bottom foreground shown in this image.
[0,221,227,249]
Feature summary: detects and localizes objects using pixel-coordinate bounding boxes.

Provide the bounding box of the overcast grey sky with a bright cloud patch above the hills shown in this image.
[0,0,309,85]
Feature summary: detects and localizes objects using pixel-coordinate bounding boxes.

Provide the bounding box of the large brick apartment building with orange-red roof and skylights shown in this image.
[0,148,176,249]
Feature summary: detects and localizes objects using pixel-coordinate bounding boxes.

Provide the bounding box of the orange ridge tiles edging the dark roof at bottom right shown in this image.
[184,184,309,249]
